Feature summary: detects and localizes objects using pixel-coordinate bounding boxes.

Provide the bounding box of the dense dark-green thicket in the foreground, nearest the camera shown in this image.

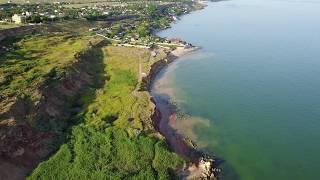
[28,125,182,180]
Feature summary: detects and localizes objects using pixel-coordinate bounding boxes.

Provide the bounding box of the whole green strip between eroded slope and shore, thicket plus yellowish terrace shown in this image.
[28,46,184,179]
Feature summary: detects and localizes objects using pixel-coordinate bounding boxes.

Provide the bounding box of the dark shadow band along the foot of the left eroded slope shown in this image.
[30,42,108,173]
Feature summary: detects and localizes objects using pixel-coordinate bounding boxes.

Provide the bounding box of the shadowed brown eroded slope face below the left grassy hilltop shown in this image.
[0,42,106,179]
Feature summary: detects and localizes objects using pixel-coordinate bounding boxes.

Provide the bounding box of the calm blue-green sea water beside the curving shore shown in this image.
[156,0,320,180]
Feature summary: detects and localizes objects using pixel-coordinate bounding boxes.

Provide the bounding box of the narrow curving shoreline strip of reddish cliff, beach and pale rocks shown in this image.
[143,46,220,179]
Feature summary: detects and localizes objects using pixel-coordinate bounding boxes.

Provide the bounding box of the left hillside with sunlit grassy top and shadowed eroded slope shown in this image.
[0,34,104,179]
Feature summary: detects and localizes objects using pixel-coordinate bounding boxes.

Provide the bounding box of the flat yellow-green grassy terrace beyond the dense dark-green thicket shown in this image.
[84,47,153,130]
